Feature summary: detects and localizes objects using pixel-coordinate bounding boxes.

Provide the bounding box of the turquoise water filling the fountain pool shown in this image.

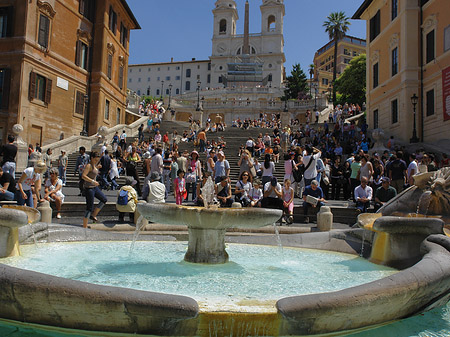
[0,242,450,337]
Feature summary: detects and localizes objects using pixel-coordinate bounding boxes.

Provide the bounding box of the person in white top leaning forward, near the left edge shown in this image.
[16,160,47,207]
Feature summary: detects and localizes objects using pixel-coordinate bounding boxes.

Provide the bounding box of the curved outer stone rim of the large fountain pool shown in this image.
[0,224,450,336]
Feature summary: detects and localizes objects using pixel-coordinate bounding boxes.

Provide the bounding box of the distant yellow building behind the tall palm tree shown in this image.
[313,35,366,94]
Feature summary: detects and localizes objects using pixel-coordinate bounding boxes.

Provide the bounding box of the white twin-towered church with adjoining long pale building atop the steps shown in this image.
[128,0,286,97]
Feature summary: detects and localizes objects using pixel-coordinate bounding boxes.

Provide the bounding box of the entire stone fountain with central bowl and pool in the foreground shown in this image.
[0,170,450,336]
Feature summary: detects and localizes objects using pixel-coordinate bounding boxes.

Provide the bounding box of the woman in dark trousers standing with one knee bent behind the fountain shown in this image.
[81,151,108,228]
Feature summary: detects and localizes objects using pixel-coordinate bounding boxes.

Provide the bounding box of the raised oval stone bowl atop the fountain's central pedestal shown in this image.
[137,203,282,230]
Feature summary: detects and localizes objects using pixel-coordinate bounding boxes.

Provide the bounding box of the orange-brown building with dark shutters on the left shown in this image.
[0,0,140,145]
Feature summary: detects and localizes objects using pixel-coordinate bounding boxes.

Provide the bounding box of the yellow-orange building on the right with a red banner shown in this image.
[353,0,450,142]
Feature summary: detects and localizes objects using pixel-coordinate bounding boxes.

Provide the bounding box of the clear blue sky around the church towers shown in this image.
[128,0,366,74]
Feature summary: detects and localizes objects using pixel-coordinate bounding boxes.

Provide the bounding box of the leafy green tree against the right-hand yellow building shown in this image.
[334,54,366,106]
